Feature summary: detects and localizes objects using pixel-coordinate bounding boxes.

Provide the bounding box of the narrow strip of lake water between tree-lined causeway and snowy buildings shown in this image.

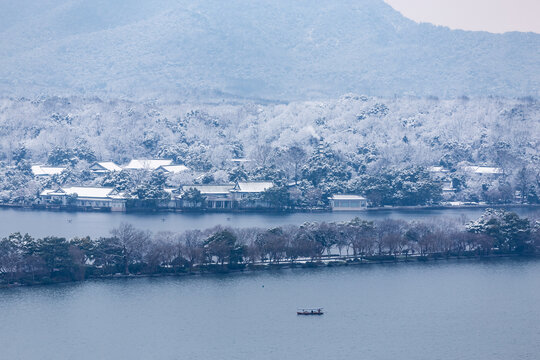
[0,207,540,237]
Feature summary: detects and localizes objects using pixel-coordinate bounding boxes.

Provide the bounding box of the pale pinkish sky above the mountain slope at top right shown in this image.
[385,0,540,33]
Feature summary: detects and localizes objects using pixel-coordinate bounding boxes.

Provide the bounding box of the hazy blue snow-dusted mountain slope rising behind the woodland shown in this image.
[0,0,540,101]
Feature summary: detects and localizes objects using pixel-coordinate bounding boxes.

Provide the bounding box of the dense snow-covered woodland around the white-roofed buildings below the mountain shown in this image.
[0,95,540,207]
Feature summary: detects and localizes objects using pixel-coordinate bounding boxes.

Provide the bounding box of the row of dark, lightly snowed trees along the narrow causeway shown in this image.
[0,209,540,285]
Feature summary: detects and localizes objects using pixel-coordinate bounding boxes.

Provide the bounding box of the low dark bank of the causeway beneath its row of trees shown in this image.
[0,253,540,290]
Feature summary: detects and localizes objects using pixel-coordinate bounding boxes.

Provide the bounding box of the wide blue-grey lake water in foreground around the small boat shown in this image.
[0,259,540,360]
